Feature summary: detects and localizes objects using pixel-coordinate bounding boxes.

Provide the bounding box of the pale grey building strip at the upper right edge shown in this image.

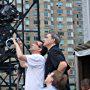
[82,0,90,43]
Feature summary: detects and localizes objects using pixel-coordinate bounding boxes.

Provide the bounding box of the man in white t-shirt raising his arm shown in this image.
[13,39,45,90]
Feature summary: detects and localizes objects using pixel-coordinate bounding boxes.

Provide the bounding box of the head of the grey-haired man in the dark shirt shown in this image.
[44,33,60,47]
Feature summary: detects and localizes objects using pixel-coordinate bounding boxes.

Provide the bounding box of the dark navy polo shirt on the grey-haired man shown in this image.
[45,45,70,90]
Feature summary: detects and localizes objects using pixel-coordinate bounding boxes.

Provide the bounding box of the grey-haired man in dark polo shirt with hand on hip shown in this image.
[44,33,70,90]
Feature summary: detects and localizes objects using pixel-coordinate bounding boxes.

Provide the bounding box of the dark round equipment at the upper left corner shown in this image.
[0,3,19,23]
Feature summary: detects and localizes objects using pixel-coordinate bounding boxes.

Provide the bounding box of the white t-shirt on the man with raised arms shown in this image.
[25,54,45,90]
